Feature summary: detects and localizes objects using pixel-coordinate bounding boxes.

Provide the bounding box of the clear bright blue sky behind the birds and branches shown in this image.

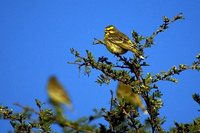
[0,0,200,132]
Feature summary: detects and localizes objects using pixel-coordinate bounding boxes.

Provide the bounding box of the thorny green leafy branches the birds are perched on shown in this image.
[0,14,200,133]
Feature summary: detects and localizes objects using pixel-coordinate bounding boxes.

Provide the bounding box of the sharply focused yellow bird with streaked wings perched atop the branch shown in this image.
[104,25,144,59]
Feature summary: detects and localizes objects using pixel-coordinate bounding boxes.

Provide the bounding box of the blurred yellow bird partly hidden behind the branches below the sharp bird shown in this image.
[117,82,147,114]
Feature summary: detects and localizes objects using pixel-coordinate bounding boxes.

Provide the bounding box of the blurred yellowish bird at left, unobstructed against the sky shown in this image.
[47,76,72,108]
